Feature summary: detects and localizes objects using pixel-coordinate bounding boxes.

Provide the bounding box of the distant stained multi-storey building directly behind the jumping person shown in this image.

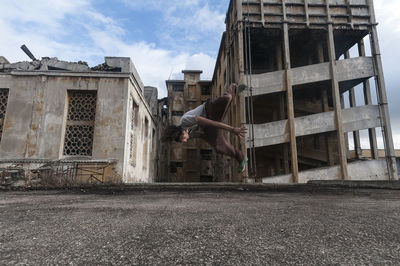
[166,70,218,182]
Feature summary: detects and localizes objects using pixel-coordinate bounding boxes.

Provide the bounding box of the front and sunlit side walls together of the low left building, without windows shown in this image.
[0,66,156,182]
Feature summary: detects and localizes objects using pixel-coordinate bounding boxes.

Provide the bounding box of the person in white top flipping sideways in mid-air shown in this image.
[163,83,247,173]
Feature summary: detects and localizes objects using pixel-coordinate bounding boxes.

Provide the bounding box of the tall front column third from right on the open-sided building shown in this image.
[282,0,299,183]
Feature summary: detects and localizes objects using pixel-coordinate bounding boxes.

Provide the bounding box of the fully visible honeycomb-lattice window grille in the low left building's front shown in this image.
[64,90,97,156]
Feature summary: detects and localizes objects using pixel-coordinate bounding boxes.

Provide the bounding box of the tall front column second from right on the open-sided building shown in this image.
[326,0,348,179]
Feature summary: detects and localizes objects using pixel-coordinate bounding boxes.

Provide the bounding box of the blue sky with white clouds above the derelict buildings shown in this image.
[0,0,400,149]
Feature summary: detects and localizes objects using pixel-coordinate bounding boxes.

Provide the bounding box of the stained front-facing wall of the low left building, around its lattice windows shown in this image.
[0,73,127,177]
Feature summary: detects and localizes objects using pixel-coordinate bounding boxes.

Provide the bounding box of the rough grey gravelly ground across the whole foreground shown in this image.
[0,189,400,265]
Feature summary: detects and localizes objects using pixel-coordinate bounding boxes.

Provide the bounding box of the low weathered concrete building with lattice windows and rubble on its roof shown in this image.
[0,57,159,184]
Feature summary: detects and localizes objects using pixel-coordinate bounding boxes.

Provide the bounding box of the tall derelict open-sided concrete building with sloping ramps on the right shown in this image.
[212,0,398,183]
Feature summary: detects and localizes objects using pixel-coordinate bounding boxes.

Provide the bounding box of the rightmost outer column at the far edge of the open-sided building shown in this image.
[368,0,399,180]
